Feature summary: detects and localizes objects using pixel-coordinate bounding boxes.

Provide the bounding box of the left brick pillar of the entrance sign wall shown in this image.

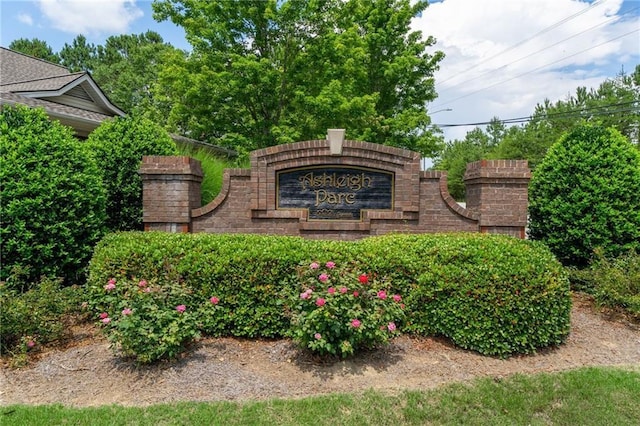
[140,156,203,232]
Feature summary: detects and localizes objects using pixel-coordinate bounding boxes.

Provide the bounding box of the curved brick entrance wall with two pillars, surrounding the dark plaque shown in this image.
[140,140,530,240]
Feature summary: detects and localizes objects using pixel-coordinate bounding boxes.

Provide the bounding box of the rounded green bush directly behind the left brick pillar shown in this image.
[87,116,177,231]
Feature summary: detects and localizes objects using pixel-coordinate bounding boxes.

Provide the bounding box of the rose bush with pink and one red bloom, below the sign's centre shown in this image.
[290,261,404,357]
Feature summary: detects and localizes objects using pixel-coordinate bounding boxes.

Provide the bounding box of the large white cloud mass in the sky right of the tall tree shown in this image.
[413,0,640,139]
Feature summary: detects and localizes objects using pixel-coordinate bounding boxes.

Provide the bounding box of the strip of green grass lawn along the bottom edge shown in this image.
[0,368,640,426]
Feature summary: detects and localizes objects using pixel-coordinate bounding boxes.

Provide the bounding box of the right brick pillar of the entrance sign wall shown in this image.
[464,160,531,238]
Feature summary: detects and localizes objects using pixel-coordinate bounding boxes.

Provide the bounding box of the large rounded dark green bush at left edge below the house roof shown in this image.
[0,107,105,288]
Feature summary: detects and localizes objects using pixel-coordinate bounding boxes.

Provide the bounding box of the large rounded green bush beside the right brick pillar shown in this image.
[529,124,640,267]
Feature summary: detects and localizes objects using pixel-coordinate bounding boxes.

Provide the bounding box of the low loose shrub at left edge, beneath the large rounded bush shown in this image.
[0,279,84,355]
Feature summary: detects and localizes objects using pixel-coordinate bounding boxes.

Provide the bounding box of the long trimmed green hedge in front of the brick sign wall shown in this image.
[88,232,571,356]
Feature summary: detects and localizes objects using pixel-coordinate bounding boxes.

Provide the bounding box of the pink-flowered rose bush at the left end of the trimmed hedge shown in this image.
[89,278,220,364]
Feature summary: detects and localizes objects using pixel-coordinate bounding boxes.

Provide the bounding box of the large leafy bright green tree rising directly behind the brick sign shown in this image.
[153,0,443,154]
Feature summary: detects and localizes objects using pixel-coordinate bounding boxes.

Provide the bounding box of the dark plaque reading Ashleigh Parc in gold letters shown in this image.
[276,166,394,220]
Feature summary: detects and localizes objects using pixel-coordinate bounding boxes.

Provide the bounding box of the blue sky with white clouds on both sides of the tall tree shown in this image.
[0,0,640,145]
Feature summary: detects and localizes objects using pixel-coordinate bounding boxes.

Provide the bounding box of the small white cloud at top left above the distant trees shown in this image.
[39,0,143,35]
